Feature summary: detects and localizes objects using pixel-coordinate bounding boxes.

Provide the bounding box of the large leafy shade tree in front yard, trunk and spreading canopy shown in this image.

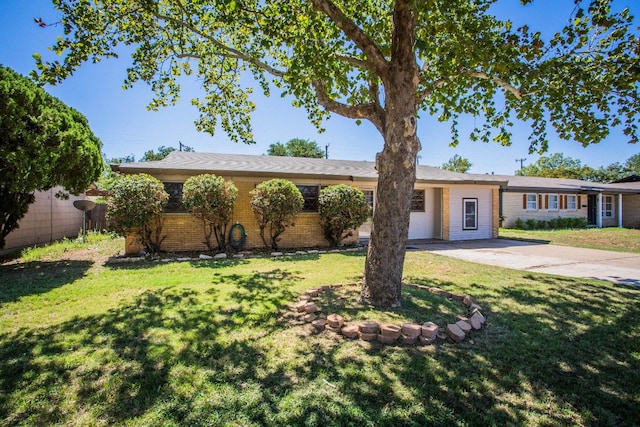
[36,0,640,306]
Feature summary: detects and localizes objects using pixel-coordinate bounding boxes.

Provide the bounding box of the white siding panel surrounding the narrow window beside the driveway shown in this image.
[449,185,493,240]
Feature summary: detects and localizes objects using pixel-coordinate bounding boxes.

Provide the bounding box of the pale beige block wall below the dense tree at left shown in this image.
[1,187,84,253]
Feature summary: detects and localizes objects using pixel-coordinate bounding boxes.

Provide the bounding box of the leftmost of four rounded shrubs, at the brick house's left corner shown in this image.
[107,173,169,253]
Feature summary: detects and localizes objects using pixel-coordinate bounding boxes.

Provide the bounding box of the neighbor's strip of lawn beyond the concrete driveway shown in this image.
[500,228,640,253]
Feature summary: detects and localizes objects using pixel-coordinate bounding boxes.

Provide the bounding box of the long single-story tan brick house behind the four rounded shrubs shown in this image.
[113,151,506,253]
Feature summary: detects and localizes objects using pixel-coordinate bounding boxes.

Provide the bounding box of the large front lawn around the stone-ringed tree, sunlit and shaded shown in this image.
[0,236,640,426]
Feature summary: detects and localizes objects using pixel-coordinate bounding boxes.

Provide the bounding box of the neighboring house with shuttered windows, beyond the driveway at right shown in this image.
[500,176,640,228]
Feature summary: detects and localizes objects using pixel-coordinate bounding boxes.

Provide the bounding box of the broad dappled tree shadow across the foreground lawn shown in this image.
[0,269,640,426]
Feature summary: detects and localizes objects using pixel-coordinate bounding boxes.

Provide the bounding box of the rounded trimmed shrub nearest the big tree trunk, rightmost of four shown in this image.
[318,184,371,246]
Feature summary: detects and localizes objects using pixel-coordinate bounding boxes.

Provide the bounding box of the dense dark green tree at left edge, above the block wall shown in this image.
[0,66,102,249]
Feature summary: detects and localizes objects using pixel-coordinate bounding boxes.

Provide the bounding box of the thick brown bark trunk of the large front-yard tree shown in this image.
[362,0,420,307]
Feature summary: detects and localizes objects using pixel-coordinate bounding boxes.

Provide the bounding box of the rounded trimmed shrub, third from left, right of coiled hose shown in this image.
[251,179,304,250]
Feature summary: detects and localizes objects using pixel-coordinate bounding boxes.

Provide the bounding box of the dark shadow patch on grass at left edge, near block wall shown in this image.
[0,260,93,303]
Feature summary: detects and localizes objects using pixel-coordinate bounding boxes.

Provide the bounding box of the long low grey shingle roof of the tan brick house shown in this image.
[115,151,506,185]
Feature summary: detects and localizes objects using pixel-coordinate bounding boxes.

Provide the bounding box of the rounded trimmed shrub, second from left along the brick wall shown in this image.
[182,174,238,251]
